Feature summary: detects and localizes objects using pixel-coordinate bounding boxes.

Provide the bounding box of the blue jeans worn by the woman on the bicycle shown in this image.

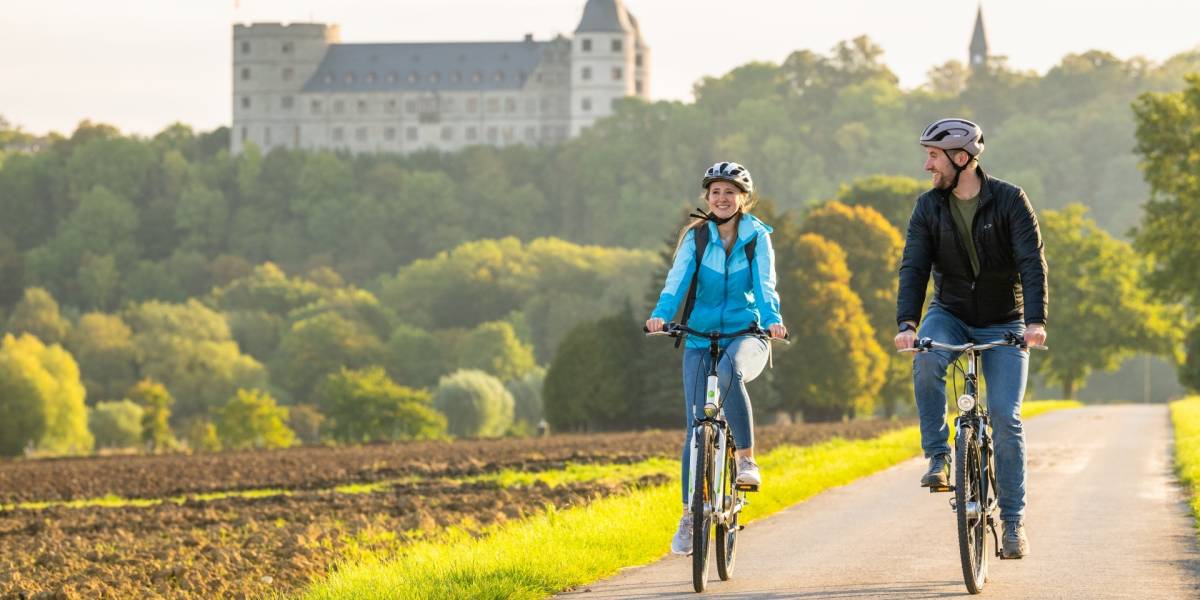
[680,336,768,504]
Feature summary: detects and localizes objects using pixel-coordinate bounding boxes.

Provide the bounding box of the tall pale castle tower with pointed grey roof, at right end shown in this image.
[570,0,649,137]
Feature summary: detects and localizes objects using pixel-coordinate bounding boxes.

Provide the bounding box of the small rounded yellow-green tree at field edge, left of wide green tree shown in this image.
[217,390,296,450]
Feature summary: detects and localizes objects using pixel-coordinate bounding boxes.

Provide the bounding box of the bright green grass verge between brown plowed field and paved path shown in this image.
[297,402,1080,599]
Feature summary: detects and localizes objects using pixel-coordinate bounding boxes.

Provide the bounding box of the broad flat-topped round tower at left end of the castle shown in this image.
[229,23,340,154]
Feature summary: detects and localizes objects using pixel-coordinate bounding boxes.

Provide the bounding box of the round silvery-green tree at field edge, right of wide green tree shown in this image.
[433,370,514,438]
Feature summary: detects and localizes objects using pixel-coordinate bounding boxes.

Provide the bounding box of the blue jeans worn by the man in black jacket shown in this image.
[912,304,1030,521]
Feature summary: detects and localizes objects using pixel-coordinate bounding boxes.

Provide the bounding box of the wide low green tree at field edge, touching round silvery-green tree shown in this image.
[317,367,446,443]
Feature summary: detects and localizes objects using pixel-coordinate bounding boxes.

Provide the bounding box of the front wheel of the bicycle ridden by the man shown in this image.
[954,424,988,594]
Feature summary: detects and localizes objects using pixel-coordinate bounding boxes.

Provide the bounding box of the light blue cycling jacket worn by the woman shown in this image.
[650,215,784,348]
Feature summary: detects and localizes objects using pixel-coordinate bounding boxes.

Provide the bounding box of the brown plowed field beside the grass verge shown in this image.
[0,421,908,599]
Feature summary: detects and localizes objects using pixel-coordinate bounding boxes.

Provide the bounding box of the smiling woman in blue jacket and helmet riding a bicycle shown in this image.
[646,162,787,554]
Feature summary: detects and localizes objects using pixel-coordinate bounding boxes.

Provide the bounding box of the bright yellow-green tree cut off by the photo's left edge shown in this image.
[0,334,95,456]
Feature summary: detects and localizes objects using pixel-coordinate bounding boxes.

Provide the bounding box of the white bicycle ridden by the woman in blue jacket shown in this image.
[643,323,787,592]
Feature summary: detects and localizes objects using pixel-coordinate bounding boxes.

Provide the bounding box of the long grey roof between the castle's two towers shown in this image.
[304,41,550,92]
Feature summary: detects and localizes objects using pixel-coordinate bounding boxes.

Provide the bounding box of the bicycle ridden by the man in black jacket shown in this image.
[900,331,1046,594]
